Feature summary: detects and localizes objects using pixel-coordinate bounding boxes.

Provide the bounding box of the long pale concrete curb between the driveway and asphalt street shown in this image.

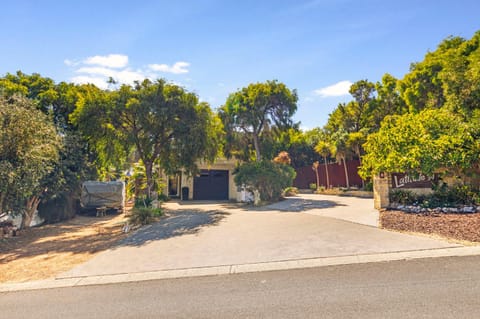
[0,246,480,292]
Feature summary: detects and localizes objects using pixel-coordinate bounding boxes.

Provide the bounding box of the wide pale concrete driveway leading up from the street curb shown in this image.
[59,194,460,278]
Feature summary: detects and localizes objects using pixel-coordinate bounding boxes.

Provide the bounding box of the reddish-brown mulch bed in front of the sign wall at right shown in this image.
[380,210,480,243]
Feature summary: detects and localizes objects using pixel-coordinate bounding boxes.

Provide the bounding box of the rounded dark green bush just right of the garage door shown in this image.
[235,161,296,201]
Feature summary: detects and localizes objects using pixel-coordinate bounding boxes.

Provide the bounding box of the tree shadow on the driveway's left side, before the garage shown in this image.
[120,209,230,246]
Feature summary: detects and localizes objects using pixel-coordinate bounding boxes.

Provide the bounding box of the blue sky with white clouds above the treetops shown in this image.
[0,0,480,128]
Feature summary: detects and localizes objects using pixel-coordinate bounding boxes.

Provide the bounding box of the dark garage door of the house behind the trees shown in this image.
[193,169,228,200]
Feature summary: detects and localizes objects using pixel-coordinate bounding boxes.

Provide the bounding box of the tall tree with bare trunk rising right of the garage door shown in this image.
[220,81,298,161]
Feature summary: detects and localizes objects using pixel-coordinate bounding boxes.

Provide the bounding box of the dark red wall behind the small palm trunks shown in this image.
[293,160,362,189]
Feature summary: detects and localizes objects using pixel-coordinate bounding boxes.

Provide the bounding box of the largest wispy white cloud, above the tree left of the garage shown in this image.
[64,54,190,89]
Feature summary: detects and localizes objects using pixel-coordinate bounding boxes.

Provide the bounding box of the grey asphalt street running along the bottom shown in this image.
[0,256,480,319]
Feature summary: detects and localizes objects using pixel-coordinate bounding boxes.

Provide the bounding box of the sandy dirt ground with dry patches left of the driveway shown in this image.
[0,214,127,283]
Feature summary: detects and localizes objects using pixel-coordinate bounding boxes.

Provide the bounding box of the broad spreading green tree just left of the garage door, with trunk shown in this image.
[73,80,222,195]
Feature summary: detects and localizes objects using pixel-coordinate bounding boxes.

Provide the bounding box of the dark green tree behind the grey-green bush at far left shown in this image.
[0,71,96,221]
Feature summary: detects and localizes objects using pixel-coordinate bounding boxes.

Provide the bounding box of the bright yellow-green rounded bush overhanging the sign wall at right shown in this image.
[360,109,480,177]
